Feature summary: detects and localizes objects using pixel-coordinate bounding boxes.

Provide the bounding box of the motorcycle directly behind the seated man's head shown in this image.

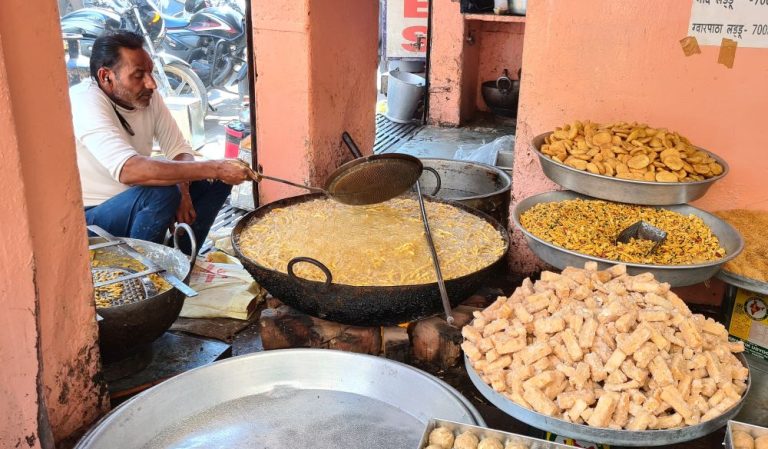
[61,0,208,111]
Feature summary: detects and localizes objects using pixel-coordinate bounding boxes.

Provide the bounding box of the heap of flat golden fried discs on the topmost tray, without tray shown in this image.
[541,120,724,182]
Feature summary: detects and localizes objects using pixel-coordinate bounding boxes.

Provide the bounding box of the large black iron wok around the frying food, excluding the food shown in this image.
[232,194,509,326]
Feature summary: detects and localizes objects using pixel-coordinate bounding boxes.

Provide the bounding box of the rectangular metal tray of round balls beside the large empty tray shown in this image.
[418,419,570,449]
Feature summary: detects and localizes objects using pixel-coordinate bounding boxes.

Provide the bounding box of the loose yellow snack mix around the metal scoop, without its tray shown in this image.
[520,199,725,265]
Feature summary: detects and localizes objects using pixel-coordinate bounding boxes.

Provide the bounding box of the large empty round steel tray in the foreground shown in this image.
[76,349,485,449]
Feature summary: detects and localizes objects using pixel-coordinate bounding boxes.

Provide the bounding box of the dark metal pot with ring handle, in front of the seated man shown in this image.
[88,237,194,358]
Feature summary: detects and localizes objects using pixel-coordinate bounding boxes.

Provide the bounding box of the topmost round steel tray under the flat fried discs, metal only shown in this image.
[531,132,728,206]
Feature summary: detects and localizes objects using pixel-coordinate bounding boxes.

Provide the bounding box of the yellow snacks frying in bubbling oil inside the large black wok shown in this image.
[239,198,505,286]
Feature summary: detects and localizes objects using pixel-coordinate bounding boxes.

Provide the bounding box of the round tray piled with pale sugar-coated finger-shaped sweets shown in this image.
[462,262,751,446]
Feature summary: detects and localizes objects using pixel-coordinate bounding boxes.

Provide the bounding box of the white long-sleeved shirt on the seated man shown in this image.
[69,79,192,207]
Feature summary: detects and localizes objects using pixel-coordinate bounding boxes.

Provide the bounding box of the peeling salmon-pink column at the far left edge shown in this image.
[0,0,108,447]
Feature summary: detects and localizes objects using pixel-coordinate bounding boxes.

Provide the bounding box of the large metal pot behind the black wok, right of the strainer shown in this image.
[419,159,512,229]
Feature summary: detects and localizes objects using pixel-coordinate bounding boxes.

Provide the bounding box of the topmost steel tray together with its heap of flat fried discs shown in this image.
[531,121,728,206]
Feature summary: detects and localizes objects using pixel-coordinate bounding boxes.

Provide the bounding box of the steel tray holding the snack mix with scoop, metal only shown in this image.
[512,190,744,287]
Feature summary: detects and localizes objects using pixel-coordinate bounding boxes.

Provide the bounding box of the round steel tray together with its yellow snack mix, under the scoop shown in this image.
[512,191,744,287]
